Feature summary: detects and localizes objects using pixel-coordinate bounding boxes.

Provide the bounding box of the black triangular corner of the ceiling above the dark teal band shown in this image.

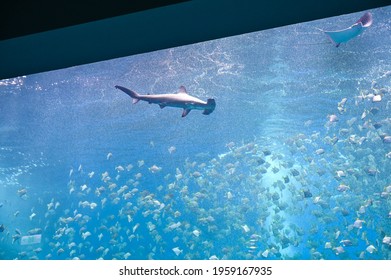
[0,0,187,40]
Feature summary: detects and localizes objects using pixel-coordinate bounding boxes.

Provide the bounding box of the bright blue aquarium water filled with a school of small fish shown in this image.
[0,7,391,259]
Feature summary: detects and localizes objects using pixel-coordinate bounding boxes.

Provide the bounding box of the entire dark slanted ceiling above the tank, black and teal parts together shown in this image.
[0,0,391,79]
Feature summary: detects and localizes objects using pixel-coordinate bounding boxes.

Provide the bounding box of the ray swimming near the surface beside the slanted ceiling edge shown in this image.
[319,12,372,47]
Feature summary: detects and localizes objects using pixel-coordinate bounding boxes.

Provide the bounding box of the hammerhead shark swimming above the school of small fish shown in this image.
[115,86,216,117]
